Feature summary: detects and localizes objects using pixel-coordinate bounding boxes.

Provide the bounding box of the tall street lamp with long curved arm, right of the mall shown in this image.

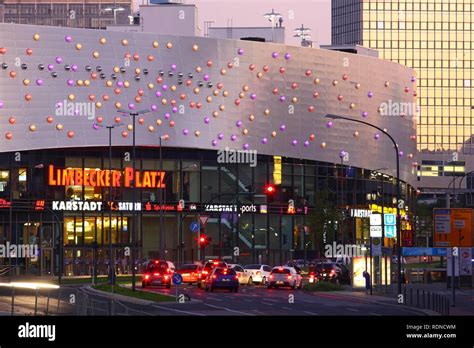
[325,114,402,295]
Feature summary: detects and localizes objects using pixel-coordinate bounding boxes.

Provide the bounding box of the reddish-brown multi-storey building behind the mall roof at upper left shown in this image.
[0,0,132,29]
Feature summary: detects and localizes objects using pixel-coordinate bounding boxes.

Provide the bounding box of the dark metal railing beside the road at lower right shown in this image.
[403,287,450,315]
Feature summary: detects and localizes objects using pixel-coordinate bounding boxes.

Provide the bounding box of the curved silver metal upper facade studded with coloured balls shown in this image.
[0,24,416,185]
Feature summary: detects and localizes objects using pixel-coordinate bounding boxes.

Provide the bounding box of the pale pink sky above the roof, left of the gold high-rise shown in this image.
[191,0,331,45]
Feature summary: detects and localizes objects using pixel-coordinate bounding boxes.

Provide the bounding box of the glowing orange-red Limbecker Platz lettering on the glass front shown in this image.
[48,165,166,188]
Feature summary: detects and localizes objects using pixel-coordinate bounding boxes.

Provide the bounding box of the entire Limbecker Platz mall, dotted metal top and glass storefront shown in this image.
[0,24,416,275]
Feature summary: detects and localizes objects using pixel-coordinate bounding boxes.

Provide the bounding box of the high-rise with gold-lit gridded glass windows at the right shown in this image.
[332,0,474,209]
